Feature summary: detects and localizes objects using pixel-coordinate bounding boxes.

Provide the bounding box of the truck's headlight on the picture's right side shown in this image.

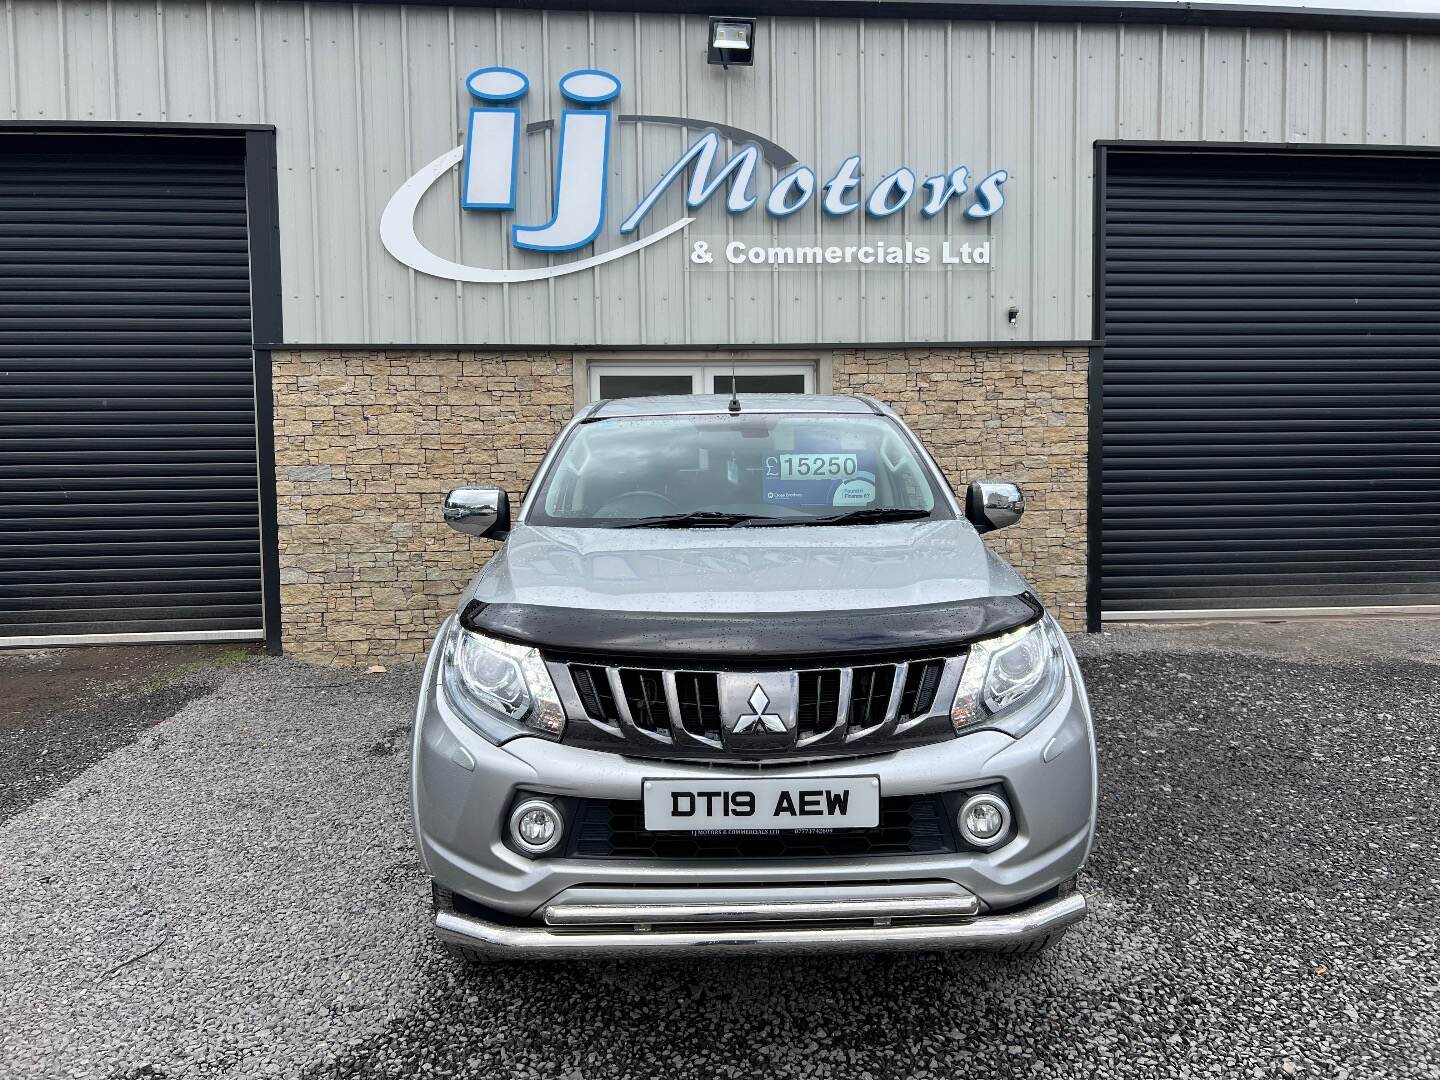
[950,616,1066,739]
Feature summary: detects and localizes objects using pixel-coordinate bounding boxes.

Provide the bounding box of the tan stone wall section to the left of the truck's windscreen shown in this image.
[272,351,575,665]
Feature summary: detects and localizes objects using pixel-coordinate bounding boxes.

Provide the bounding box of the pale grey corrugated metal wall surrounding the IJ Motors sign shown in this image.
[0,0,1440,344]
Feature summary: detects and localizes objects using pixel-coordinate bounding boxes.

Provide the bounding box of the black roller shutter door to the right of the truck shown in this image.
[1100,148,1440,616]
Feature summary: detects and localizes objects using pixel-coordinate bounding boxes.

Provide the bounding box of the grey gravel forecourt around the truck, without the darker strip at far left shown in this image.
[0,622,1440,1080]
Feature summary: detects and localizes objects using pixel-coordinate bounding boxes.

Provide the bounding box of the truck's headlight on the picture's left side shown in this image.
[441,624,564,743]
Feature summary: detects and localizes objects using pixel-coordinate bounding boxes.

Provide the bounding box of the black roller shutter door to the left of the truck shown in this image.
[0,135,261,644]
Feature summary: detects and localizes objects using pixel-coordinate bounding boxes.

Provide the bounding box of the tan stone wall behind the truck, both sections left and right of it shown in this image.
[274,350,1086,665]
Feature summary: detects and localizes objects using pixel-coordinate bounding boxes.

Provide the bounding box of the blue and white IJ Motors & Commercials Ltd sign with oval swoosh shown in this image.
[380,68,1009,284]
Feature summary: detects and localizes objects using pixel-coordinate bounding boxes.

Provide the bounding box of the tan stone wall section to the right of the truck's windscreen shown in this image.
[832,348,1089,631]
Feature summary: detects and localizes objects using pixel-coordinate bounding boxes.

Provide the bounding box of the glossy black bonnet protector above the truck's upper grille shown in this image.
[459,593,1044,662]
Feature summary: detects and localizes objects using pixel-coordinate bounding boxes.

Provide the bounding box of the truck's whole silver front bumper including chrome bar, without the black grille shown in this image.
[412,622,1096,958]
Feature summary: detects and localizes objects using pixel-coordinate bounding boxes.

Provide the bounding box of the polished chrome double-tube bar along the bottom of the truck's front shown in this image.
[435,893,1087,960]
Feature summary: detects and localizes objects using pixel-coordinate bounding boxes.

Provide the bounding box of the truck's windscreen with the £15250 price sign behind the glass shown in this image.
[530,415,948,526]
